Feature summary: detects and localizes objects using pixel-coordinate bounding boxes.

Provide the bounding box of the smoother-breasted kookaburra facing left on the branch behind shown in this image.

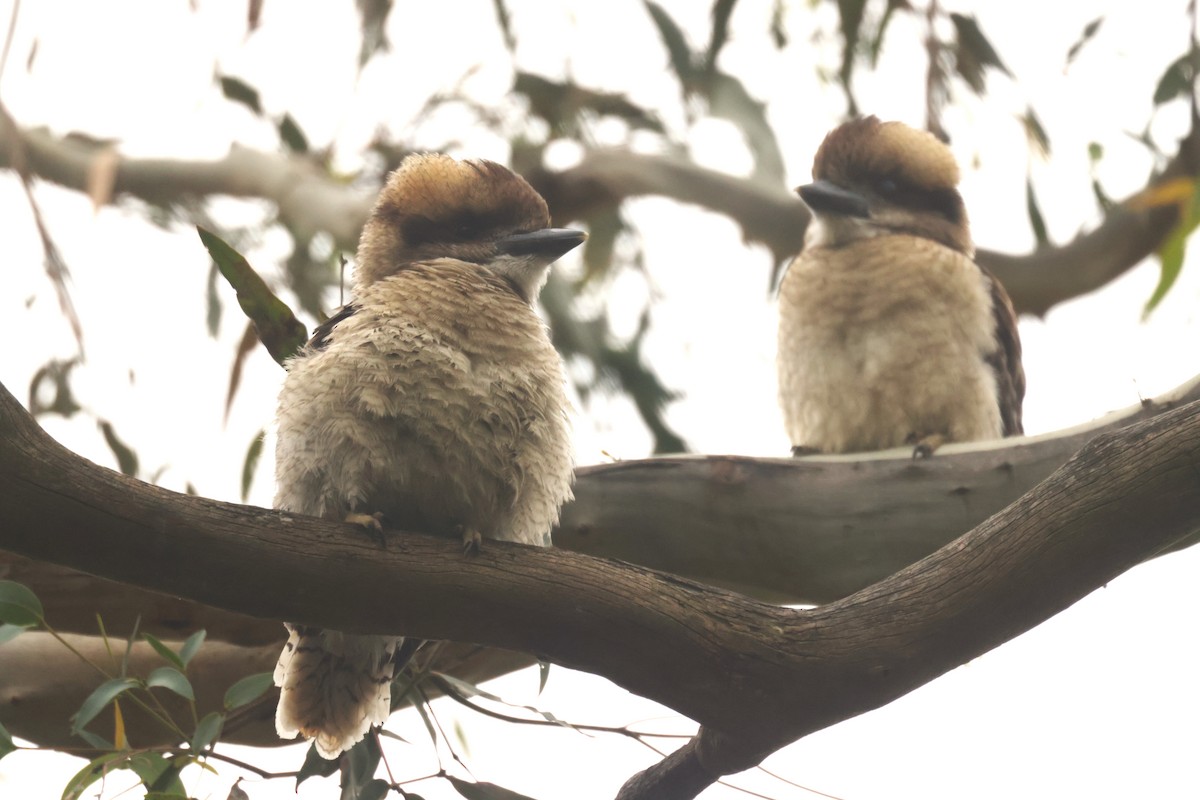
[778,116,1025,456]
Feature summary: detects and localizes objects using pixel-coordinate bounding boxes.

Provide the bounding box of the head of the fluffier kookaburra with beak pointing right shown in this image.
[354,154,587,302]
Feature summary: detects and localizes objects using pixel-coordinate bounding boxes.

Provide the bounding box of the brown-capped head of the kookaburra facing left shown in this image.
[797,116,972,255]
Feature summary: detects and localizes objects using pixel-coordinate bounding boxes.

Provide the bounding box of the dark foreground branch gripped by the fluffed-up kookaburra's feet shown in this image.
[0,379,1200,796]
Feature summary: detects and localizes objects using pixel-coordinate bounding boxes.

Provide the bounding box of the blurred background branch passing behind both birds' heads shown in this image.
[0,119,1200,314]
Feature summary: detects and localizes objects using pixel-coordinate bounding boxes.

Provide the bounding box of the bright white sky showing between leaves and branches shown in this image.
[0,0,1200,800]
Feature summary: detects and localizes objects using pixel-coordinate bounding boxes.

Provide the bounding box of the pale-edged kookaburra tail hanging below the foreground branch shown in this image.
[275,625,403,759]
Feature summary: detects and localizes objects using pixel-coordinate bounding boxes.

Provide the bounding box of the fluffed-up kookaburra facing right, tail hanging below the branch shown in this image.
[275,155,584,758]
